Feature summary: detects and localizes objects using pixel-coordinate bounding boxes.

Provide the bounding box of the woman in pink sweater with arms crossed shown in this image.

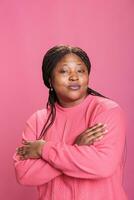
[14,45,127,200]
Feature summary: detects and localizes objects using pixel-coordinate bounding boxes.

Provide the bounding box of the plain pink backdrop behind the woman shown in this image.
[0,0,134,200]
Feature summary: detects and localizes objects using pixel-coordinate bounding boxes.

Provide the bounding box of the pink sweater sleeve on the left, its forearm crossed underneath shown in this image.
[13,113,61,186]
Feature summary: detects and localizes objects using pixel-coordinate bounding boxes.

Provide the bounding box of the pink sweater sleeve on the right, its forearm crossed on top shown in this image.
[42,106,126,179]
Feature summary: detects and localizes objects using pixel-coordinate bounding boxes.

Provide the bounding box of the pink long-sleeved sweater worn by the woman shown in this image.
[14,95,127,200]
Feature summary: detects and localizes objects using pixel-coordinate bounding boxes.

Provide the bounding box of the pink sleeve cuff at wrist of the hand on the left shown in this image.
[41,141,55,161]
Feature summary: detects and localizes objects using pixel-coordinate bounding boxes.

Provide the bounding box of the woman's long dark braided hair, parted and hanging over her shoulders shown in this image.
[39,45,105,139]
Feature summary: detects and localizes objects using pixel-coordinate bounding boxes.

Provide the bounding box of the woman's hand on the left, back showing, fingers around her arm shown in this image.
[17,140,46,160]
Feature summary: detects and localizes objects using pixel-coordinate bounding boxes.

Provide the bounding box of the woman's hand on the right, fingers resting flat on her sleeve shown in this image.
[74,123,107,146]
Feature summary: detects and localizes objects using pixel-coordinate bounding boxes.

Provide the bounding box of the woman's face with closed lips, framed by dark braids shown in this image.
[51,53,89,107]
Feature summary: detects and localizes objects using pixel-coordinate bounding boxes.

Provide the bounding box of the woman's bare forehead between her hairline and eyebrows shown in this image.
[57,53,84,65]
